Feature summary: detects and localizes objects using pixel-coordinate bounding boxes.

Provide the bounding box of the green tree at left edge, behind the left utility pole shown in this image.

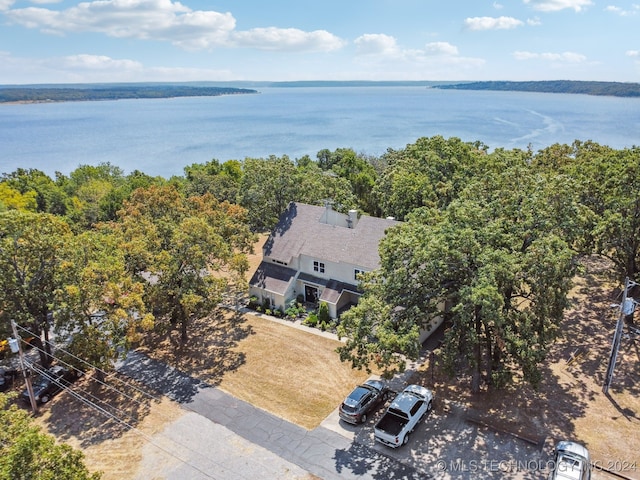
[0,210,71,366]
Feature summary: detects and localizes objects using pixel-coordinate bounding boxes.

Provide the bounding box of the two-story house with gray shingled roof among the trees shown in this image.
[249,203,400,318]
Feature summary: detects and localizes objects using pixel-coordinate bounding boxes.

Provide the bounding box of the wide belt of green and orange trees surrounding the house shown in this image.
[0,136,640,391]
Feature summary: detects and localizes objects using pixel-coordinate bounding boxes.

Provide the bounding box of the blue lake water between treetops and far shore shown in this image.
[0,86,640,178]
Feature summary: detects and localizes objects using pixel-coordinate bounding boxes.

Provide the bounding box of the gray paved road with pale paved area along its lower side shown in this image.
[118,352,430,480]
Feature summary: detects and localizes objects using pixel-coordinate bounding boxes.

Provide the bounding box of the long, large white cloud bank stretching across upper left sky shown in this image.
[5,0,344,51]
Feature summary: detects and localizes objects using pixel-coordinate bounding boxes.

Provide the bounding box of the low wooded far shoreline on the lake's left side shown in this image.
[0,85,258,103]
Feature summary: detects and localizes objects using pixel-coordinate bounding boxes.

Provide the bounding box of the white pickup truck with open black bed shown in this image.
[373,385,433,448]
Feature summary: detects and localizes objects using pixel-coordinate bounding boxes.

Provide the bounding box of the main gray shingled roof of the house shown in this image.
[264,203,399,270]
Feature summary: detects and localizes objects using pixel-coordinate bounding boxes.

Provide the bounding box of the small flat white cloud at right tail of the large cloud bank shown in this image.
[232,27,345,52]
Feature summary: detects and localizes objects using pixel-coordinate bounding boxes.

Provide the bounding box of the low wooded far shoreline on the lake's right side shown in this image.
[433,80,640,97]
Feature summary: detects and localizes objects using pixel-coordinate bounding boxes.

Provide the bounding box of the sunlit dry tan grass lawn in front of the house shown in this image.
[219,315,368,429]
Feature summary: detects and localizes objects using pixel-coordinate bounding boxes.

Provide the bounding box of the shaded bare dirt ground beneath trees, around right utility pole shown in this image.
[411,259,640,478]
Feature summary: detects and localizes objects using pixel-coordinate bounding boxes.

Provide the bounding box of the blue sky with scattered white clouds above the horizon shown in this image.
[0,0,640,85]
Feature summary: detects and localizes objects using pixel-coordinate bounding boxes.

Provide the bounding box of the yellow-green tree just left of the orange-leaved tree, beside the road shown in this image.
[56,227,153,375]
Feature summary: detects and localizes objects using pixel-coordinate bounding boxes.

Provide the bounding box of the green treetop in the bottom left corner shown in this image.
[0,393,101,480]
